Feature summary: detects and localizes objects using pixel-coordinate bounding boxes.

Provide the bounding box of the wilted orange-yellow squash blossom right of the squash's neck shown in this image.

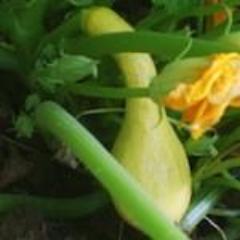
[165,53,240,138]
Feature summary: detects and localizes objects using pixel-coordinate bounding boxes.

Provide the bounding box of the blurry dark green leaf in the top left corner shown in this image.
[0,0,48,48]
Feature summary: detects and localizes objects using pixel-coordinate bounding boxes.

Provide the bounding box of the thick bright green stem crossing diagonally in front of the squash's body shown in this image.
[36,102,188,240]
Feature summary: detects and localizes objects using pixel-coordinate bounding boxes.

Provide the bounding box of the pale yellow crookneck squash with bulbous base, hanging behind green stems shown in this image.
[82,7,191,225]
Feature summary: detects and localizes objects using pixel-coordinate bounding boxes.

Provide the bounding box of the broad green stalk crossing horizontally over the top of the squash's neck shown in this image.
[64,32,240,60]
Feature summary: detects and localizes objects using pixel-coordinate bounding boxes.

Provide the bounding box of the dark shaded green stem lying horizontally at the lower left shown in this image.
[0,193,107,218]
